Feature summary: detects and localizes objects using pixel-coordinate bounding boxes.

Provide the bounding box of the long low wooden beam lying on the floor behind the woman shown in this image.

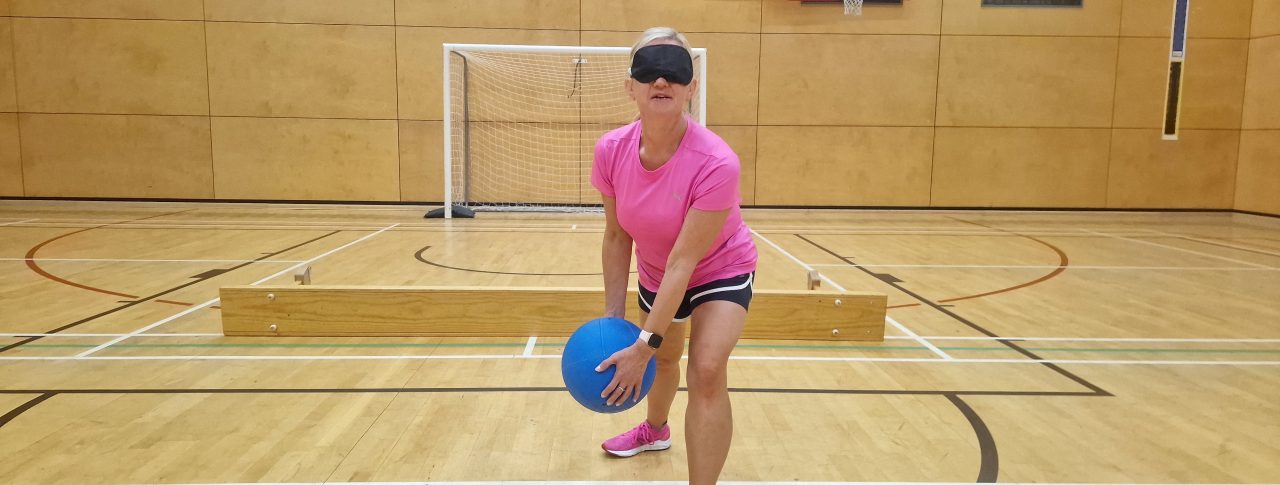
[221,285,887,342]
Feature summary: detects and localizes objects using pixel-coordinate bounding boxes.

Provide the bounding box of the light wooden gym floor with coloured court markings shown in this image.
[0,201,1280,484]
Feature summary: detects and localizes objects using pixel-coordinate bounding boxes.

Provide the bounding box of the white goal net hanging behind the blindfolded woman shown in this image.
[444,45,705,211]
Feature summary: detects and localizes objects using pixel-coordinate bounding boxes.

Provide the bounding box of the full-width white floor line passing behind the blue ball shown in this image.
[0,353,1280,366]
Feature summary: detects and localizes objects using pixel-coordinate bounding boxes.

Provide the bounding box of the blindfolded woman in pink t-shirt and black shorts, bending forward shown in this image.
[591,27,756,484]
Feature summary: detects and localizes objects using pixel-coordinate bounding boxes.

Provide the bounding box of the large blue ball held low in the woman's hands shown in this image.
[561,317,658,413]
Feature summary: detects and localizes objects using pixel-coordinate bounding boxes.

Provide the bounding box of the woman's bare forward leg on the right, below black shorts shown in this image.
[685,301,746,485]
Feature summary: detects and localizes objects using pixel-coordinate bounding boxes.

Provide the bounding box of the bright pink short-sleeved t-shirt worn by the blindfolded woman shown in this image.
[591,115,756,292]
